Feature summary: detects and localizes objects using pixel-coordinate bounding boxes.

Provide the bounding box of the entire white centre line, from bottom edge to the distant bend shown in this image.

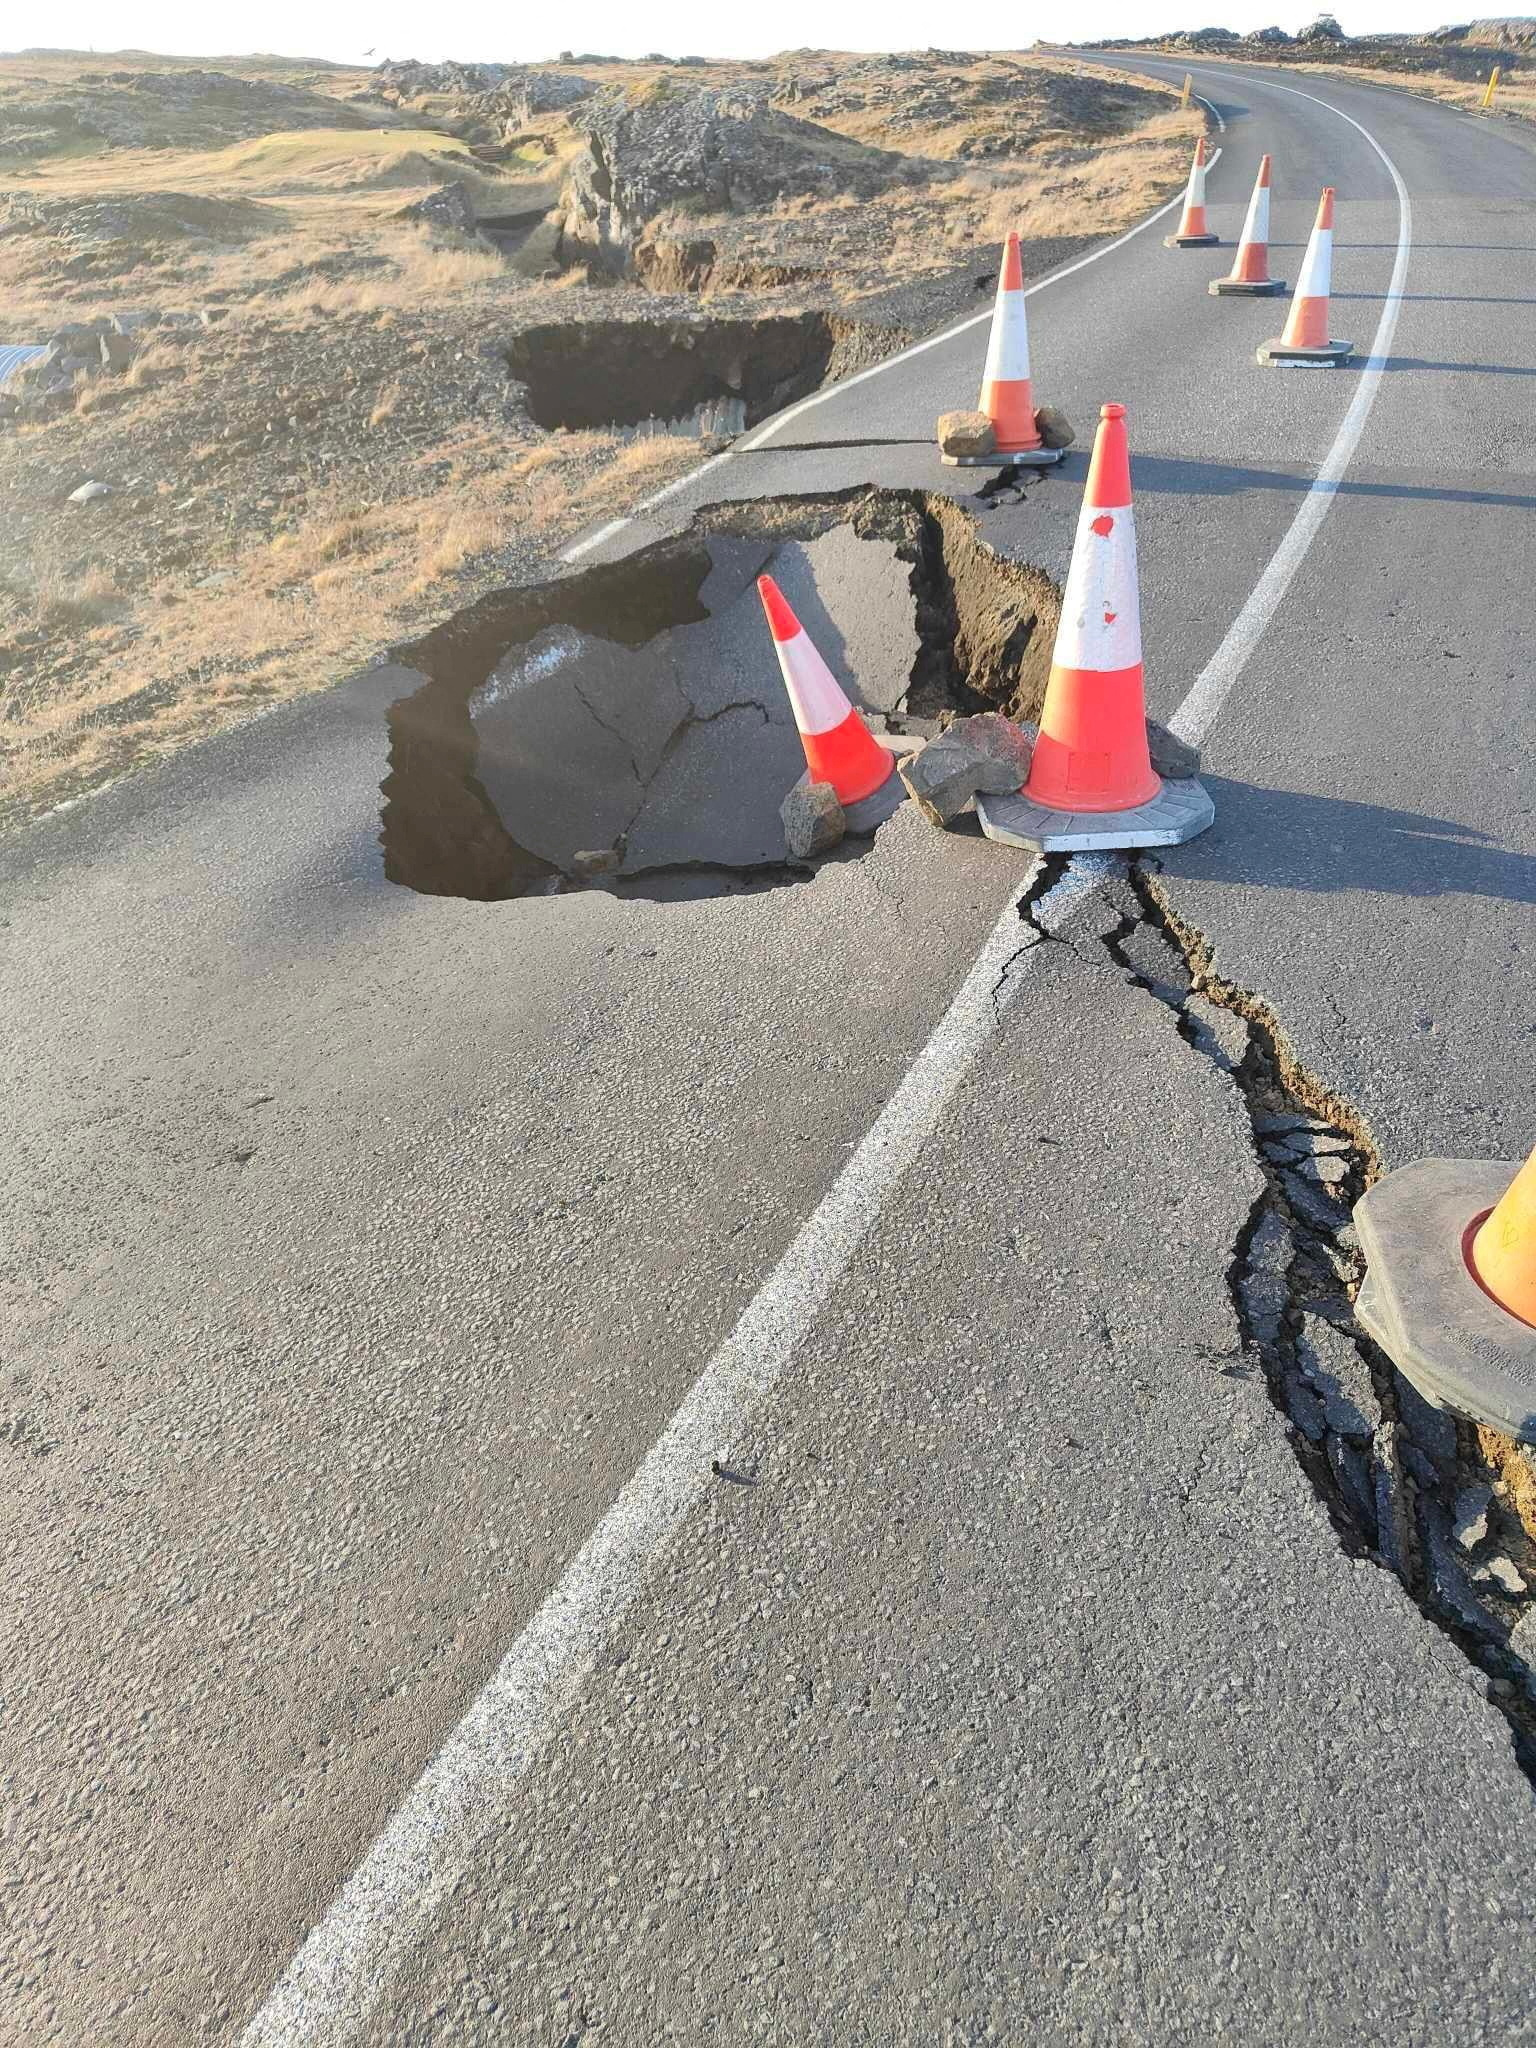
[242,72,1409,2048]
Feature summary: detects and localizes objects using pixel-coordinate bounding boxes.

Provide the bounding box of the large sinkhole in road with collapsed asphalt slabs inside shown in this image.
[381,489,1059,901]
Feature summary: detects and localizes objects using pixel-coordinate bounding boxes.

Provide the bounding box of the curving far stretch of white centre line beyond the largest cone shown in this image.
[1171,80,1413,745]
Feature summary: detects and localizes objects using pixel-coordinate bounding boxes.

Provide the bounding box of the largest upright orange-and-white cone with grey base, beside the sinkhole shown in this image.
[977,406,1217,854]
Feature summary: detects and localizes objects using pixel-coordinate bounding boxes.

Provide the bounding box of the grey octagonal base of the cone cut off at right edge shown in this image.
[1354,1159,1536,1444]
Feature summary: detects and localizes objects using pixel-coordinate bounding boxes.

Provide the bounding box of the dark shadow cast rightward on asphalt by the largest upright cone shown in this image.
[1163,774,1536,903]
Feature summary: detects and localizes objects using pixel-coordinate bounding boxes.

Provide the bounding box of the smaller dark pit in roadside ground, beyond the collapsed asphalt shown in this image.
[508,313,907,434]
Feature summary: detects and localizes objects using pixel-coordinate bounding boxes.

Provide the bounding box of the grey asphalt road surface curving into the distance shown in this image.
[0,56,1536,2048]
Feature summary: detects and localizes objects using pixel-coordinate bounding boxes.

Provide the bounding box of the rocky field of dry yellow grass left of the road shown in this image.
[0,51,1196,817]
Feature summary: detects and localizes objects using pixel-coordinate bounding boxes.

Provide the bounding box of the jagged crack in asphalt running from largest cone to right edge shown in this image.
[1020,856,1536,1784]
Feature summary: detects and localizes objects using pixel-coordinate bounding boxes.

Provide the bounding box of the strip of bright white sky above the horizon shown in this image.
[6,0,1466,63]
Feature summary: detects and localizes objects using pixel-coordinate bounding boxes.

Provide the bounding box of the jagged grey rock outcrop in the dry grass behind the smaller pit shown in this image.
[559,80,903,272]
